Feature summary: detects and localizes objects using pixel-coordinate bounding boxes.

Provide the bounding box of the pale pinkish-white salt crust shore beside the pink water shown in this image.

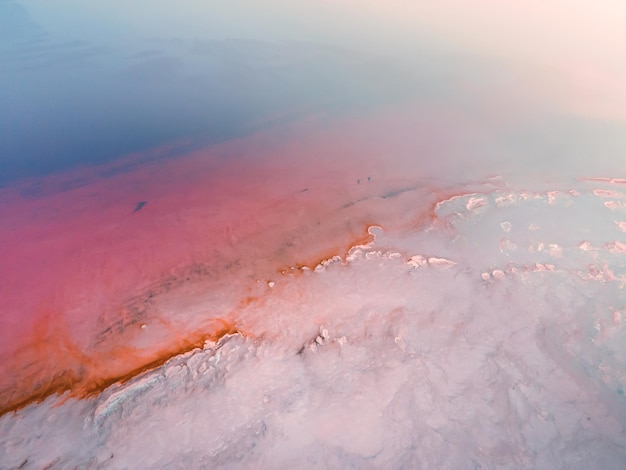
[0,176,626,469]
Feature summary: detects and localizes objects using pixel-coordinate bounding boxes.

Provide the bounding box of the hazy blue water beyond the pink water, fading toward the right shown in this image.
[0,1,408,185]
